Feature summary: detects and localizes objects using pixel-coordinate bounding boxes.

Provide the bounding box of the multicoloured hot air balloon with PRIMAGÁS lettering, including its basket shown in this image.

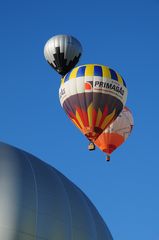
[59,64,127,150]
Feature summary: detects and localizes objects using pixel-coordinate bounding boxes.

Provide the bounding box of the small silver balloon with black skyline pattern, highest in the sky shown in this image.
[44,35,82,75]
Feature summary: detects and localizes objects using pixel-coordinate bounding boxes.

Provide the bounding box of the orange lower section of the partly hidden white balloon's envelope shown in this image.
[95,133,124,154]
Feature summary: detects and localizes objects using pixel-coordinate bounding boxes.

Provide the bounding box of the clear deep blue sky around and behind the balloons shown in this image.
[0,0,159,240]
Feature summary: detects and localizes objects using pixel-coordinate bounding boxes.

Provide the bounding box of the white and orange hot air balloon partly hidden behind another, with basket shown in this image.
[95,107,134,161]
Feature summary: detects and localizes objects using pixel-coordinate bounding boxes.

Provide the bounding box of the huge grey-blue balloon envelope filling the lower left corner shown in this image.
[0,143,112,240]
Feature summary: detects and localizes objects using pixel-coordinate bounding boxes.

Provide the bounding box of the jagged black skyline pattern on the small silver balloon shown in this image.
[48,47,81,76]
